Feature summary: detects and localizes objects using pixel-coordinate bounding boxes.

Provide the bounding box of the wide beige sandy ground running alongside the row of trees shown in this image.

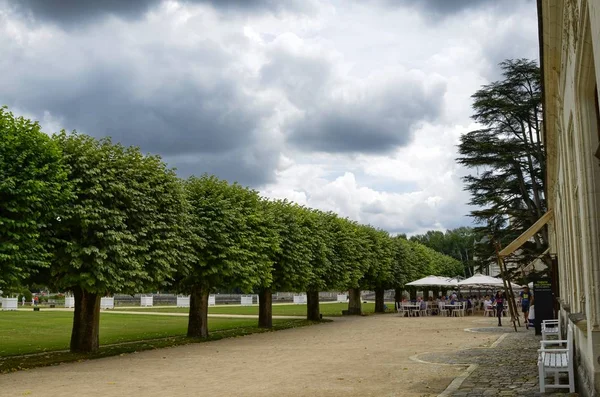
[0,315,499,397]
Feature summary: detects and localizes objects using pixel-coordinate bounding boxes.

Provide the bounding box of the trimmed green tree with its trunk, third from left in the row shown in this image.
[180,175,278,337]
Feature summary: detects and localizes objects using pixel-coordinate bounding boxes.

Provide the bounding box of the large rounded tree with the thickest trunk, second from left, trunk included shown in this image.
[50,131,188,351]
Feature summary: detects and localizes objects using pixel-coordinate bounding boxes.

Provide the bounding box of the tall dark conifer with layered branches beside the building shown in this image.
[457,59,548,276]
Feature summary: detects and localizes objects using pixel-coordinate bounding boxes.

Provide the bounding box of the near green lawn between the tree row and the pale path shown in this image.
[0,309,289,357]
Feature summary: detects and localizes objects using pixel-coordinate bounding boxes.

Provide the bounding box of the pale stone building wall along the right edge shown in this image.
[540,0,600,395]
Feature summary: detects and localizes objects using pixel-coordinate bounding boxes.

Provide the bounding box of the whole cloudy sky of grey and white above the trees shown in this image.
[0,0,538,234]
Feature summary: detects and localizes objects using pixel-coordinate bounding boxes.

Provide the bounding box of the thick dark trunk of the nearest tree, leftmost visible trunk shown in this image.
[70,288,100,353]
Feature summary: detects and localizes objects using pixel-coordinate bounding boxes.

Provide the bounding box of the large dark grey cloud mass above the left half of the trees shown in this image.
[0,23,279,185]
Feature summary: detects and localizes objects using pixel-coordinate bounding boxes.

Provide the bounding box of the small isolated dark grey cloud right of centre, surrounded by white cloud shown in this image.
[288,79,444,153]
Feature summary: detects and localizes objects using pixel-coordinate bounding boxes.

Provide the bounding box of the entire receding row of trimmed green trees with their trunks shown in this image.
[0,108,462,352]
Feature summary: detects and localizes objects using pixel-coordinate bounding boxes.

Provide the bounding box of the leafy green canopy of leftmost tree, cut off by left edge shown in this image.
[0,108,69,293]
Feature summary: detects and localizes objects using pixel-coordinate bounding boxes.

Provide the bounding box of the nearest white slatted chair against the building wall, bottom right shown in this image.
[538,325,575,393]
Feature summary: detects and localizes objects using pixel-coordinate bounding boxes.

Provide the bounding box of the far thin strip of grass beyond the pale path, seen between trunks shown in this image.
[115,303,394,317]
